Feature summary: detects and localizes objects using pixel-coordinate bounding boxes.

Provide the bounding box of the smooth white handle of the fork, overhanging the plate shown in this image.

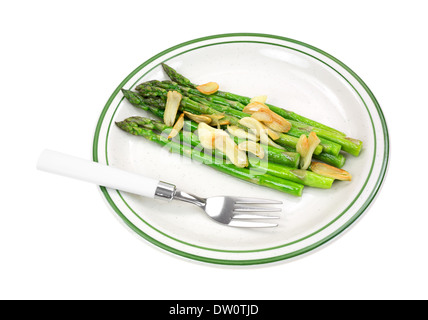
[37,150,162,198]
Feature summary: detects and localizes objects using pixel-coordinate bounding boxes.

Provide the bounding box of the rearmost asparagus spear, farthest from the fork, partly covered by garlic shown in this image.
[162,63,361,146]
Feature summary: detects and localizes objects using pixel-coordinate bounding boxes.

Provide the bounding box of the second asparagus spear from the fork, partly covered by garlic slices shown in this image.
[120,117,334,189]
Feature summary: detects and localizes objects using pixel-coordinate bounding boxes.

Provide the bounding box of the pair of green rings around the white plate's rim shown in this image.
[93,33,389,265]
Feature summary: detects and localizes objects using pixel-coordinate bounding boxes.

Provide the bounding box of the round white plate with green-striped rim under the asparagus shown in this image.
[93,34,389,265]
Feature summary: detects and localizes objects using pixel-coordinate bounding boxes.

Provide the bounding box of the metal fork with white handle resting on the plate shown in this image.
[37,150,282,228]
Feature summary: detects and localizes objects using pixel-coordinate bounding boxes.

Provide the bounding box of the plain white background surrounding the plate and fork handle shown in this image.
[0,0,428,299]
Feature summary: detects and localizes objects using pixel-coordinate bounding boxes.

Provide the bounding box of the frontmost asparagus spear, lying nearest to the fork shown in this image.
[116,121,304,196]
